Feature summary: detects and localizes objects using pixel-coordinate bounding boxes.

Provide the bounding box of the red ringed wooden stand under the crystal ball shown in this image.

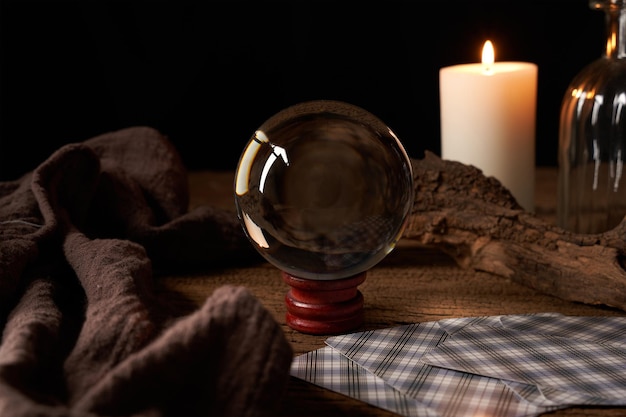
[282,272,365,334]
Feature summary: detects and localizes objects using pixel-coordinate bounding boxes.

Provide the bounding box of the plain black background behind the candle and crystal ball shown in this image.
[0,0,604,180]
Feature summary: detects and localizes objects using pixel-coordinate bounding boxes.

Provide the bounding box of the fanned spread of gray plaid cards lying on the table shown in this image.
[291,313,626,417]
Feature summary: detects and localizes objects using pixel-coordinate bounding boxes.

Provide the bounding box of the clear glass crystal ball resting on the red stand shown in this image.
[235,100,413,280]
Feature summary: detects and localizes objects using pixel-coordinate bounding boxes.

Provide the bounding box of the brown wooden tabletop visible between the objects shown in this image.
[157,167,626,416]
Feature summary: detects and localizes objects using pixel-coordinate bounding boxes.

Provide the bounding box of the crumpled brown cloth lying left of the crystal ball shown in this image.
[0,127,293,417]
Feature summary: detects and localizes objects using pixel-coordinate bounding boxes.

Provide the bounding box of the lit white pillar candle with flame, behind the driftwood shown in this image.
[439,41,537,212]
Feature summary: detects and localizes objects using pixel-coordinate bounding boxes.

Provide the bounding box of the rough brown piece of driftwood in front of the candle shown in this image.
[403,152,626,310]
